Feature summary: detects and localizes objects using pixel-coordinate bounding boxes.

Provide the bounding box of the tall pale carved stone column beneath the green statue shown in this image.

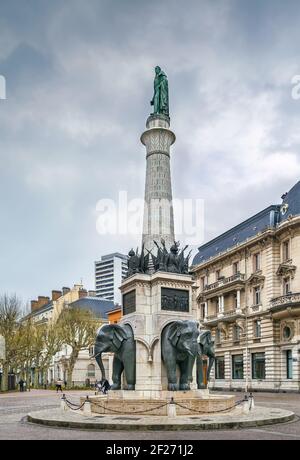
[141,114,176,250]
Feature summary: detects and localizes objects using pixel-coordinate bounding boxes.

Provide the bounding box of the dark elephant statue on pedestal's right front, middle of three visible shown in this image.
[161,320,199,391]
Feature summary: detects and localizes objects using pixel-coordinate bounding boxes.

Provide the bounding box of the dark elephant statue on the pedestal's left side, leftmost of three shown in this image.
[95,324,136,390]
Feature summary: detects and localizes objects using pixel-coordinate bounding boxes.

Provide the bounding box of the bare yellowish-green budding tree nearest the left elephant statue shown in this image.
[57,307,100,388]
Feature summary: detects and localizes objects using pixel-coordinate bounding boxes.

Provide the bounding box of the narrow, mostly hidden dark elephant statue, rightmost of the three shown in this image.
[197,330,215,389]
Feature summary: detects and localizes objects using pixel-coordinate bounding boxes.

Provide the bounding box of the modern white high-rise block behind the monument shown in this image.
[95,252,128,305]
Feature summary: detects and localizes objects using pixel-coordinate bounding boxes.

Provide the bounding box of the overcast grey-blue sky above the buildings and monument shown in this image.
[0,0,300,301]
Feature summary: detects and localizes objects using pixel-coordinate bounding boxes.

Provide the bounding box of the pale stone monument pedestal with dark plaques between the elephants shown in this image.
[120,272,197,392]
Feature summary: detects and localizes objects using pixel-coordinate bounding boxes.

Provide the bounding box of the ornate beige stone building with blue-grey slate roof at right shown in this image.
[192,182,300,391]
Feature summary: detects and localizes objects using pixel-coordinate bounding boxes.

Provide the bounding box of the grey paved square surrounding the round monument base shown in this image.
[0,390,300,441]
